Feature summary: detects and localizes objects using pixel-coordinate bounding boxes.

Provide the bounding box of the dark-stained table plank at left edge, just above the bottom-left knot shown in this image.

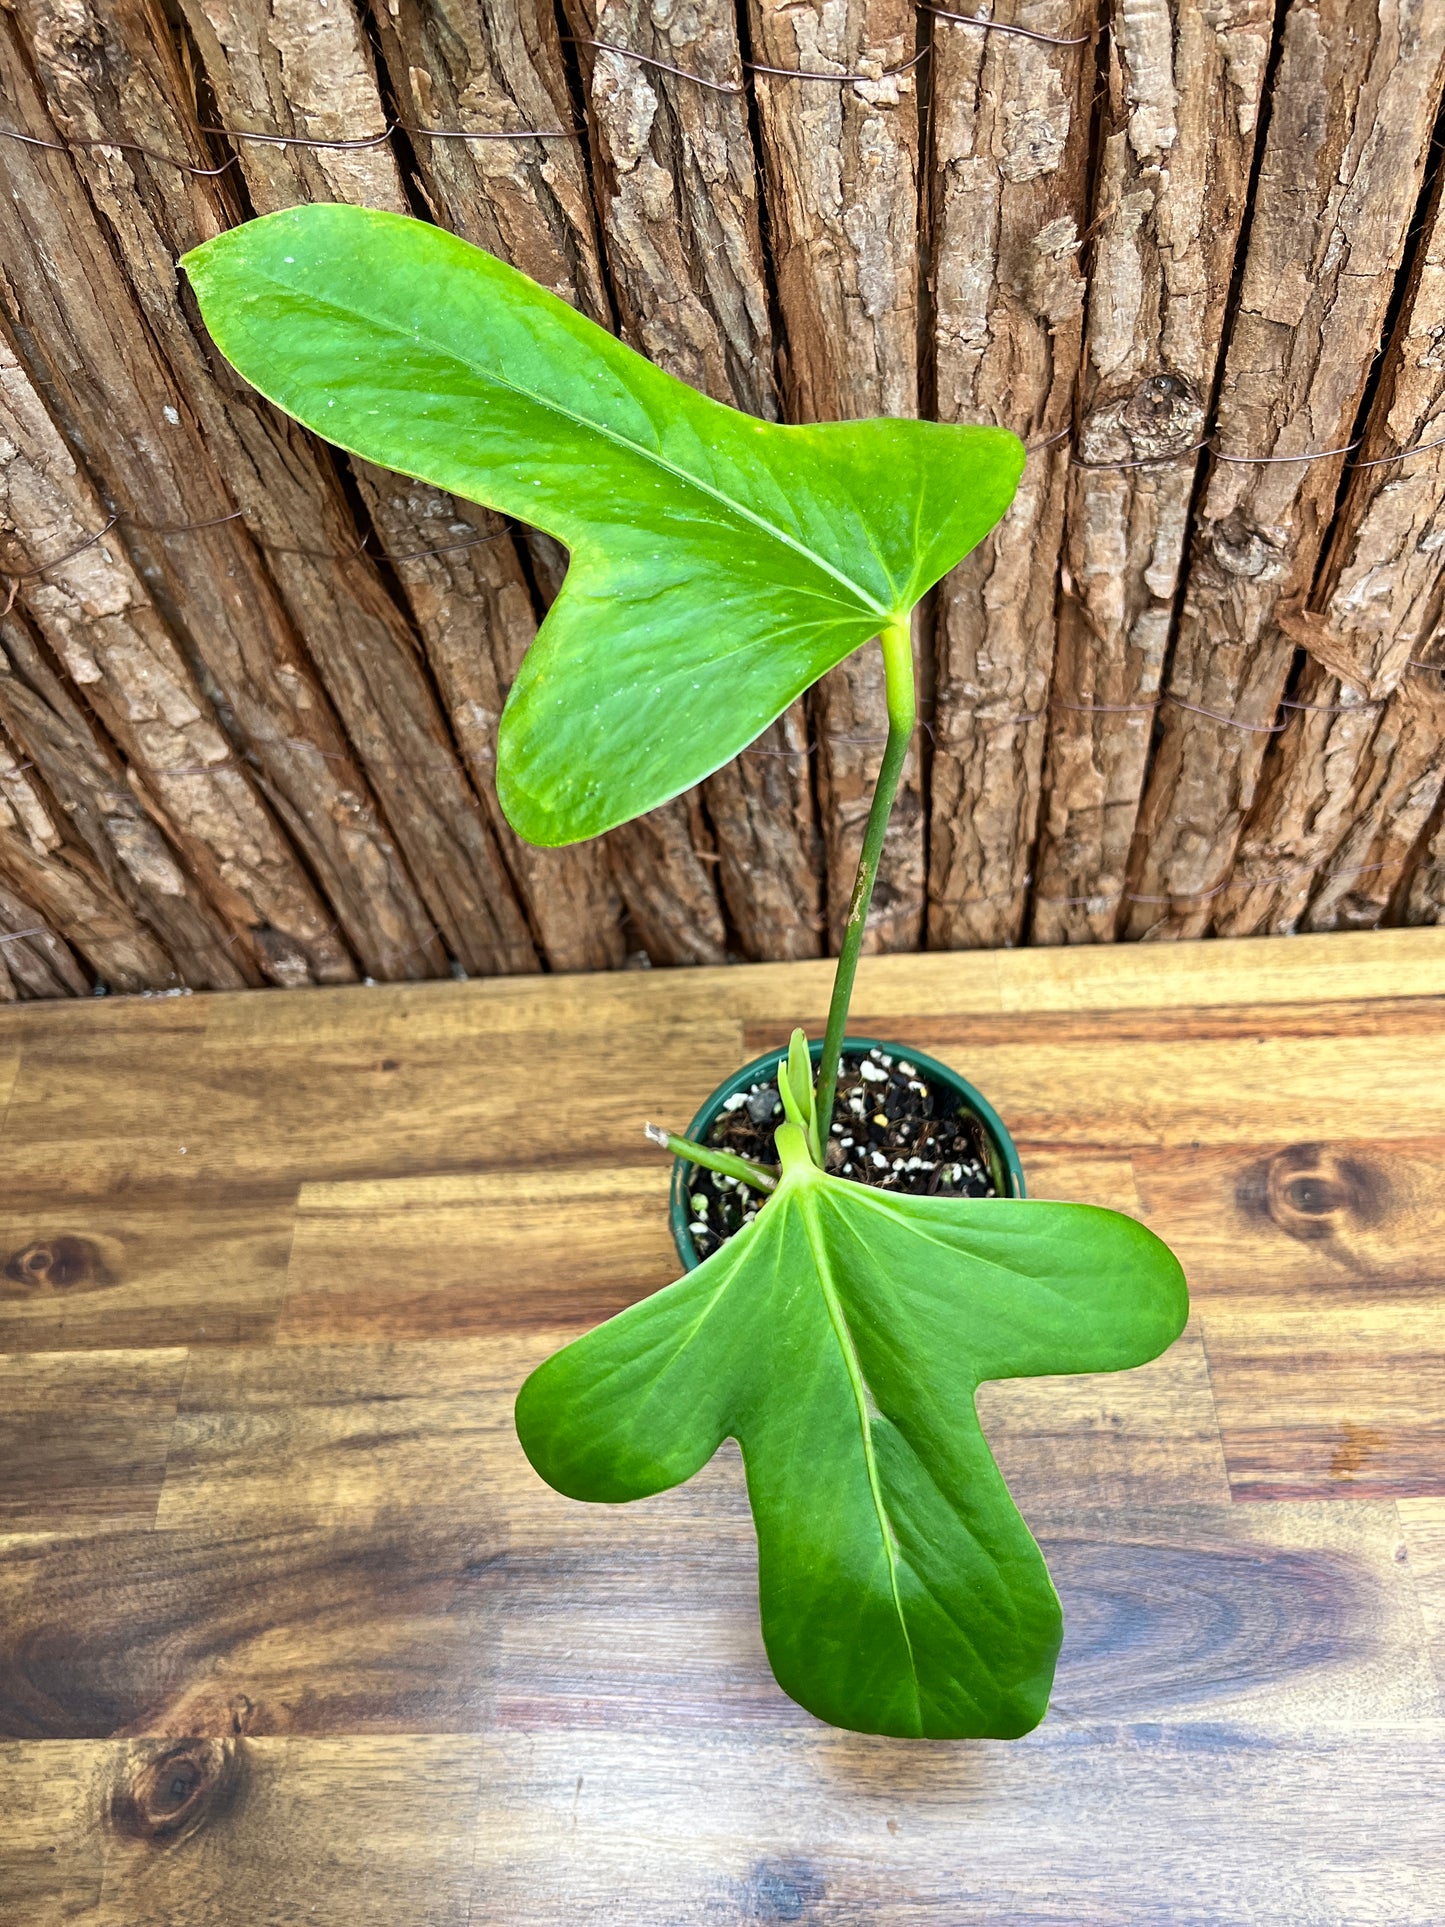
[0,1505,507,1740]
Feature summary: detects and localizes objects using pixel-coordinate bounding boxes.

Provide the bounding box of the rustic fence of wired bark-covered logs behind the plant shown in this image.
[0,0,1445,998]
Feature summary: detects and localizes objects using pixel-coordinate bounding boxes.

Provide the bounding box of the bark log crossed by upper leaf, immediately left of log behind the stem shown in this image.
[566,0,823,958]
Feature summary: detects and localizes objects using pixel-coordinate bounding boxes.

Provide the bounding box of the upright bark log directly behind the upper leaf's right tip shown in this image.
[929,0,1094,950]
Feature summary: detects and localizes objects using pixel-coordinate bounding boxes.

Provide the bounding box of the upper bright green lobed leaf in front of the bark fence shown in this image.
[183,206,1023,844]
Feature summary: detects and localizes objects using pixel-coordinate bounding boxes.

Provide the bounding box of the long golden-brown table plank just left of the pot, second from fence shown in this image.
[6,998,742,1191]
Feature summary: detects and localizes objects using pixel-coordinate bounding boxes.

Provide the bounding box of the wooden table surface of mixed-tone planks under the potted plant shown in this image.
[0,931,1445,1927]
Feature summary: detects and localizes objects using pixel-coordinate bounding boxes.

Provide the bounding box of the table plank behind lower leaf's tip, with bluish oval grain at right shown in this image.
[497,1479,1439,1738]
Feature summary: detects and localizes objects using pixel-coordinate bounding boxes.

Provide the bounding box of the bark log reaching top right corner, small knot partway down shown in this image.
[1125,0,1445,937]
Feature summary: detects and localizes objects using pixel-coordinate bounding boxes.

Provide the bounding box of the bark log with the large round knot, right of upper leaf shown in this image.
[1033,0,1274,944]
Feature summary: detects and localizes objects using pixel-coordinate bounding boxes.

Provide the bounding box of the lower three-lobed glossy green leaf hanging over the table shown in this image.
[516,1125,1189,1738]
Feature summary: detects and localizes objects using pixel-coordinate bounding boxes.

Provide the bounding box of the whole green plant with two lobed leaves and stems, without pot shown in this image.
[185,206,1187,1738]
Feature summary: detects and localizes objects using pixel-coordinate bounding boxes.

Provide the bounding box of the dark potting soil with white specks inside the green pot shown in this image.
[688,1050,1002,1258]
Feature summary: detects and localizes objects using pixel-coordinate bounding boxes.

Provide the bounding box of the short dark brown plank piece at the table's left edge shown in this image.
[0,1349,185,1530]
